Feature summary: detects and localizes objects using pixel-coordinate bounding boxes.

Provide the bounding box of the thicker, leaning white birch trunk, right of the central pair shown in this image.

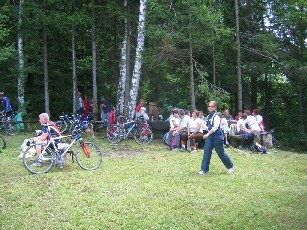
[128,0,146,118]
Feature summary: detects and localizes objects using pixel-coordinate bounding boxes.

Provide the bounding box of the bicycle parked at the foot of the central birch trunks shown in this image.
[107,116,153,145]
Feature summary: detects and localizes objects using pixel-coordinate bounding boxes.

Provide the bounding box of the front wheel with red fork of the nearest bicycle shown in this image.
[76,142,102,170]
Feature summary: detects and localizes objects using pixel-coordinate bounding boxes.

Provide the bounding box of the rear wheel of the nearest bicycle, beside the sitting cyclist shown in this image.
[22,144,56,174]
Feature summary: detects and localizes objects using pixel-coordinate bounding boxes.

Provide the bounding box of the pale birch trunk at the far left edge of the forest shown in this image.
[17,0,25,112]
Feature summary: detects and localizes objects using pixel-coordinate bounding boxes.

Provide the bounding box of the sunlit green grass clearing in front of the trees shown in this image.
[0,133,307,229]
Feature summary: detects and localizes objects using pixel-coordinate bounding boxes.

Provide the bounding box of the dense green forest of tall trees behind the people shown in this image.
[0,0,307,150]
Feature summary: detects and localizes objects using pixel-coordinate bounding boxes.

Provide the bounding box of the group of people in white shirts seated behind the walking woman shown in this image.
[166,108,264,153]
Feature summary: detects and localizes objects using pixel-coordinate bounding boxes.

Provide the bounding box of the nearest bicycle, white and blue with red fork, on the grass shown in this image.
[22,125,102,174]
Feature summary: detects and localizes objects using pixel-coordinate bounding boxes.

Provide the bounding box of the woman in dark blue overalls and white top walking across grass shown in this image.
[198,101,234,175]
